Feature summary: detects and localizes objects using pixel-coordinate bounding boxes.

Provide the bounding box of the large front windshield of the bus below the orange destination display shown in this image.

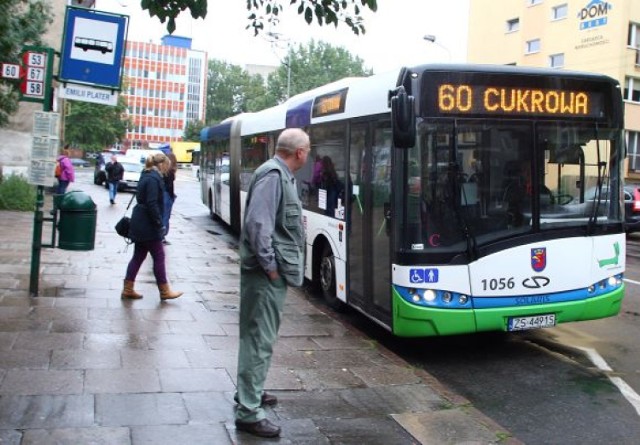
[398,119,622,254]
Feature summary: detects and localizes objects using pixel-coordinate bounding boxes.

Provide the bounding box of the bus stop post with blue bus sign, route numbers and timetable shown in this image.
[21,6,128,296]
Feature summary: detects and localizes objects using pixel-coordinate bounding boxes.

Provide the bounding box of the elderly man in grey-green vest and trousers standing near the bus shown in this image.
[235,128,310,437]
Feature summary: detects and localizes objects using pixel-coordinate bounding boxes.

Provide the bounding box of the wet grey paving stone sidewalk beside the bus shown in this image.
[0,175,519,445]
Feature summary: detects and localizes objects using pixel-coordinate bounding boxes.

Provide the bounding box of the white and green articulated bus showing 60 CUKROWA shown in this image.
[200,65,625,337]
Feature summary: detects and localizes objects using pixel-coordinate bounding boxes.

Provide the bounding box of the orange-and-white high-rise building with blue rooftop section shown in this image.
[122,35,207,148]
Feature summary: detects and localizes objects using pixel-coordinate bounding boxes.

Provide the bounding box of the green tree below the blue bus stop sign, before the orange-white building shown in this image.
[64,96,130,152]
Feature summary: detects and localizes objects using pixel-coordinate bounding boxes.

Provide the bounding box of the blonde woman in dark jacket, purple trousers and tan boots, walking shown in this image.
[121,153,182,300]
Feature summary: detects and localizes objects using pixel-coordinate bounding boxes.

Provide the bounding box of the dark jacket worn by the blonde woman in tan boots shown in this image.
[129,168,164,242]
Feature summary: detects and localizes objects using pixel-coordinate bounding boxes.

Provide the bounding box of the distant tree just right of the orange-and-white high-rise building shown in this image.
[207,60,276,124]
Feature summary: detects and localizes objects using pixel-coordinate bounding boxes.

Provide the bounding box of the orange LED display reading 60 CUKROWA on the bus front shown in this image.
[436,83,603,118]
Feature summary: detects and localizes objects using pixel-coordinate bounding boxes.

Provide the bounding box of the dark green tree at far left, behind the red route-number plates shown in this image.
[0,0,52,126]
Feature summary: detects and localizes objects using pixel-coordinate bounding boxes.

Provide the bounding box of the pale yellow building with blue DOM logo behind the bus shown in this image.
[467,0,640,181]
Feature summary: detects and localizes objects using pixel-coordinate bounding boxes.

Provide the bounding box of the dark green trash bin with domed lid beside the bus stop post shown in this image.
[58,190,97,250]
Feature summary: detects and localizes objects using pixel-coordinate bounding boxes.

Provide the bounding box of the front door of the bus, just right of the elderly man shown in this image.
[347,122,391,323]
